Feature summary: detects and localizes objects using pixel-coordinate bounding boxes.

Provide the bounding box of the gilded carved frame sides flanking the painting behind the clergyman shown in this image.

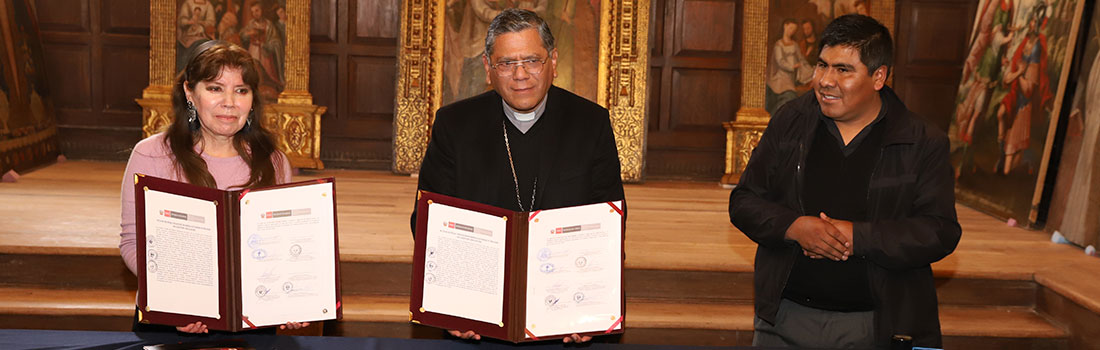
[393,0,649,182]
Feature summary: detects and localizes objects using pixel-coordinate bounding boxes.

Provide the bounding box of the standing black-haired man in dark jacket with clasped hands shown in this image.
[729,14,961,348]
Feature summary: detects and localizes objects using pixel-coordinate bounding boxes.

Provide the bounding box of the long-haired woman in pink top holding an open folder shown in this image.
[119,41,309,332]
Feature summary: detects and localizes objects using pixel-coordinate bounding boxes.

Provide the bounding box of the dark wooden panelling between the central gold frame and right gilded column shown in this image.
[646,0,744,181]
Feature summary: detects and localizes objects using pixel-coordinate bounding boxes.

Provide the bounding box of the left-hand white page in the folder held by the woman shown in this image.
[145,189,221,318]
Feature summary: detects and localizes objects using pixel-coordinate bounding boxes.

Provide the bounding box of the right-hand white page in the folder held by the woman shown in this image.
[234,183,337,327]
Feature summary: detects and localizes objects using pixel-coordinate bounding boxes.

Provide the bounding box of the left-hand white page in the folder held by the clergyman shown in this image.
[421,203,508,325]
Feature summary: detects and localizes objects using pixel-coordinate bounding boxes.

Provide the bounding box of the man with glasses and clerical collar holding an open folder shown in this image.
[410,9,625,342]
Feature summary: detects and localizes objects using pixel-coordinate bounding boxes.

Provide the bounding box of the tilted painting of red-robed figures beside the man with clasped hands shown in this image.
[948,0,1085,225]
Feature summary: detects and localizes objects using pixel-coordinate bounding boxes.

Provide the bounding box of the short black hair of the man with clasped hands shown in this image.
[817,14,893,76]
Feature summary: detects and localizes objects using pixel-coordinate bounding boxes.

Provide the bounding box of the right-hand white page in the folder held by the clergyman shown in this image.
[525,201,623,337]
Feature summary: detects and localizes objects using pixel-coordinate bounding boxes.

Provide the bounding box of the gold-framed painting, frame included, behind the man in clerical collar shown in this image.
[394,0,649,182]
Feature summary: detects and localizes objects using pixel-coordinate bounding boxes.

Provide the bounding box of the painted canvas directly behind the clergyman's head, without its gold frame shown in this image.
[442,0,600,106]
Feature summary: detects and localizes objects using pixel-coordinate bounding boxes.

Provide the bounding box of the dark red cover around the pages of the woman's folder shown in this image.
[134,174,343,331]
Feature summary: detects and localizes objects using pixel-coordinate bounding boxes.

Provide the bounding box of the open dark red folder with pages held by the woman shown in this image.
[134,174,343,331]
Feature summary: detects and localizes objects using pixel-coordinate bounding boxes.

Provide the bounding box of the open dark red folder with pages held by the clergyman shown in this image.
[409,190,626,342]
